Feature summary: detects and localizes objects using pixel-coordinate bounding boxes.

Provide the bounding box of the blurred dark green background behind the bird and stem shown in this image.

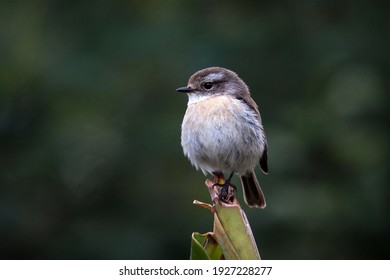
[0,0,390,259]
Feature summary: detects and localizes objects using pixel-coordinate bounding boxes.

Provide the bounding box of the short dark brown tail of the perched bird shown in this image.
[240,170,266,208]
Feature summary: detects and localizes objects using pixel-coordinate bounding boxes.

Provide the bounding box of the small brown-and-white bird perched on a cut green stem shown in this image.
[176,67,268,208]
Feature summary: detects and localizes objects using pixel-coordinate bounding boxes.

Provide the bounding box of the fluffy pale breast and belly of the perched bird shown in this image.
[181,96,265,174]
